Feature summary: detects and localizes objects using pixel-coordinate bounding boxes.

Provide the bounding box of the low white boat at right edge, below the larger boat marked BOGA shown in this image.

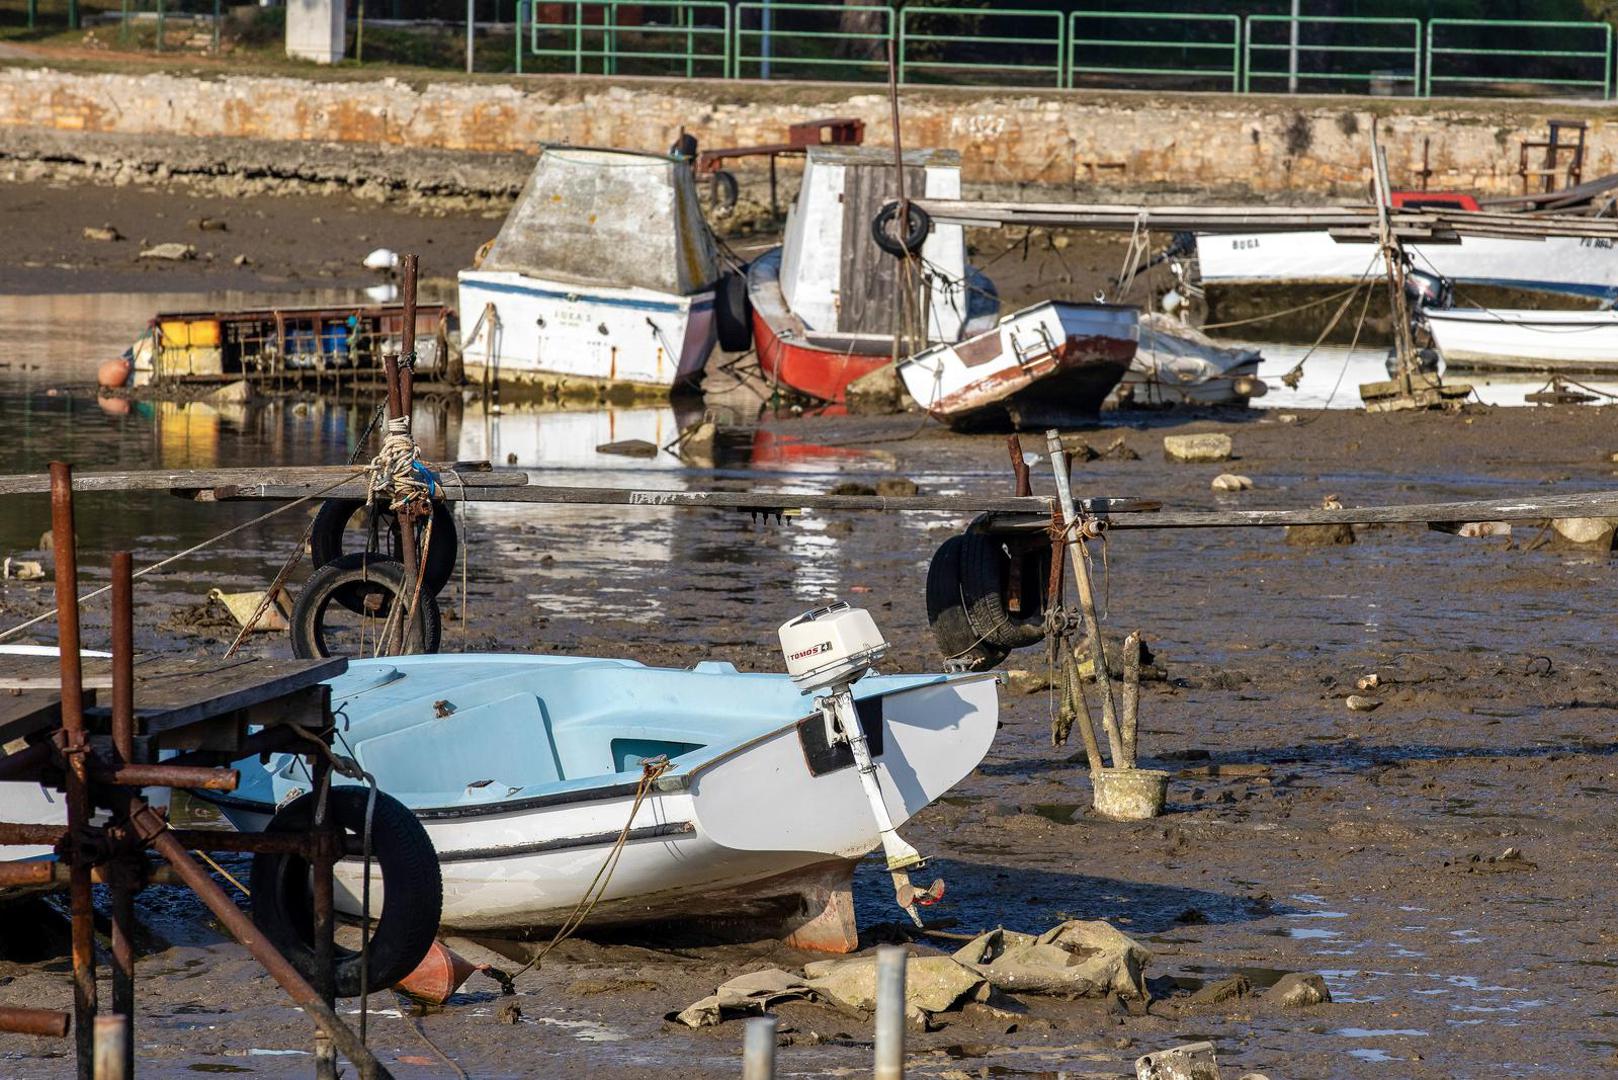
[1421,308,1618,374]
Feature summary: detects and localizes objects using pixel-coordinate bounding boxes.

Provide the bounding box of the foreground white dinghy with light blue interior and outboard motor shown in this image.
[210,604,998,952]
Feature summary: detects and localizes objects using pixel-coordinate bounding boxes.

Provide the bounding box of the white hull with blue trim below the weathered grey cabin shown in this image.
[460,270,718,392]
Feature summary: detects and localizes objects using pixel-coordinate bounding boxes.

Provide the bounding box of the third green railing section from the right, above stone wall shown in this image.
[1068,11,1241,92]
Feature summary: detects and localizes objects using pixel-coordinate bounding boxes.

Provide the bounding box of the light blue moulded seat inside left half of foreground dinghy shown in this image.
[354,693,565,793]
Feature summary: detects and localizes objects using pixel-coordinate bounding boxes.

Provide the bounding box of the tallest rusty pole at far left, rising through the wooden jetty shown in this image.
[50,461,95,1080]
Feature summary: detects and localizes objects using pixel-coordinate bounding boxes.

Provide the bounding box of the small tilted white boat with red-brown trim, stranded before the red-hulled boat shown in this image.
[898,301,1141,427]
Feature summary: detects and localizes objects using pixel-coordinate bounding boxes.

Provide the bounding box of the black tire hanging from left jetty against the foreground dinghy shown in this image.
[251,784,443,997]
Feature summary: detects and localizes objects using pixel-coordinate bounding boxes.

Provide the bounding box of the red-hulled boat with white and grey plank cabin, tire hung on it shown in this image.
[748,146,1000,403]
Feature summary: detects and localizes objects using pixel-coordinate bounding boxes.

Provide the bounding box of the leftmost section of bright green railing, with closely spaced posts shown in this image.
[516,0,735,79]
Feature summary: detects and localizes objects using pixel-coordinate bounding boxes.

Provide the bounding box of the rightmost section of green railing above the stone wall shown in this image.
[1427,19,1613,99]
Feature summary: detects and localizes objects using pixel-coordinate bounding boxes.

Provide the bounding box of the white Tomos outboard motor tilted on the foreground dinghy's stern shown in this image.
[780,601,943,926]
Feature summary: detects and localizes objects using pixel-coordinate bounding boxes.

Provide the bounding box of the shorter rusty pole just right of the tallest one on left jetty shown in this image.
[106,551,135,1080]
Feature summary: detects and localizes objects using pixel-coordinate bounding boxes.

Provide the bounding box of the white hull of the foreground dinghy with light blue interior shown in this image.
[214,667,998,947]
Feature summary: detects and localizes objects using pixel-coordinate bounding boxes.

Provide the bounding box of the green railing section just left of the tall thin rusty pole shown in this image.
[731,2,898,81]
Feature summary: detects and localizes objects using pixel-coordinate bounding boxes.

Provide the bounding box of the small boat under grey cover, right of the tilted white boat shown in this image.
[1112,318,1269,406]
